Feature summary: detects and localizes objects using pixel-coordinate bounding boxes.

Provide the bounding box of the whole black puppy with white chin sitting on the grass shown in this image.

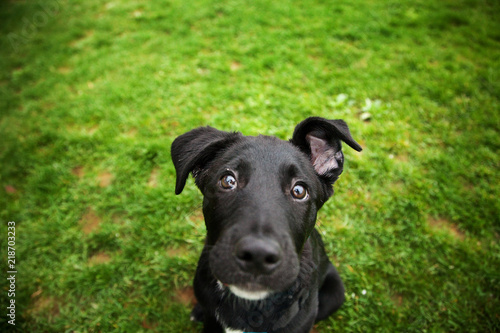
[171,117,361,333]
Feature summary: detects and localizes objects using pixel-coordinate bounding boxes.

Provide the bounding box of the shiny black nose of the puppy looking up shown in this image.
[235,236,282,274]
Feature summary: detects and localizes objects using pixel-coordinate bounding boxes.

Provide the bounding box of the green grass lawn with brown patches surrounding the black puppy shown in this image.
[0,0,500,332]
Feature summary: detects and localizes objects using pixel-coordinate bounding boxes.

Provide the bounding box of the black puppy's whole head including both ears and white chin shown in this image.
[171,117,361,299]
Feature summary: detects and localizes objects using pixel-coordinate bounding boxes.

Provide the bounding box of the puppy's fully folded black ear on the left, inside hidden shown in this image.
[170,126,242,194]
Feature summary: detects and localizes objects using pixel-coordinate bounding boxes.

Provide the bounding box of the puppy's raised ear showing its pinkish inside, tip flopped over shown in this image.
[290,117,362,184]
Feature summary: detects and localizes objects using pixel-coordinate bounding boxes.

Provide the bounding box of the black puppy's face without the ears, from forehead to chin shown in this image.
[198,137,320,297]
